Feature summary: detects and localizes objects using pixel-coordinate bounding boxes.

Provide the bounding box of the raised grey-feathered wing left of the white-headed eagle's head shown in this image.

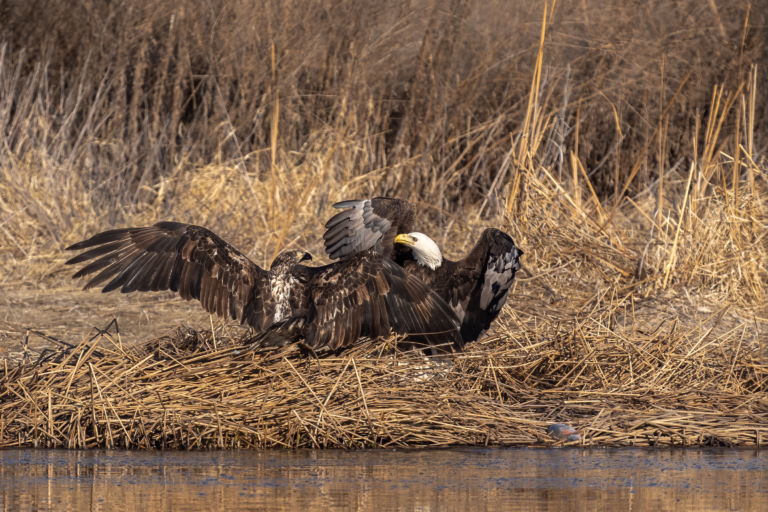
[323,197,416,261]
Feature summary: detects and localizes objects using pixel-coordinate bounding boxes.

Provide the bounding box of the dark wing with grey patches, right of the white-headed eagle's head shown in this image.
[456,229,523,342]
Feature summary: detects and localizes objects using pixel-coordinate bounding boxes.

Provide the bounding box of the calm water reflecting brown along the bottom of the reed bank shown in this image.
[0,449,768,512]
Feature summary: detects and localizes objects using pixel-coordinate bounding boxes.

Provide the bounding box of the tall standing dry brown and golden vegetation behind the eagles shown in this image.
[0,0,768,332]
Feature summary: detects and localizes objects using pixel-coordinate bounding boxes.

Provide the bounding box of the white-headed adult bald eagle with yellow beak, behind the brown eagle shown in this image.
[323,197,523,343]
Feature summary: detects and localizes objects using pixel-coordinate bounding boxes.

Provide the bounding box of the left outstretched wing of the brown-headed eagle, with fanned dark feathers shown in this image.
[67,222,275,331]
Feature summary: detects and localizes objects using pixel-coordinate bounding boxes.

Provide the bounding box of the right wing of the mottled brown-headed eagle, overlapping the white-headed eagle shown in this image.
[306,251,463,352]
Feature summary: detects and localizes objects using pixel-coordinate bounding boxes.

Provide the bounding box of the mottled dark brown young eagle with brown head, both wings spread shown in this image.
[67,222,463,353]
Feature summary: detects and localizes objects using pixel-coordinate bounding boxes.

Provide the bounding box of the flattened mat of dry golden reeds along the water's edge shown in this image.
[0,306,768,450]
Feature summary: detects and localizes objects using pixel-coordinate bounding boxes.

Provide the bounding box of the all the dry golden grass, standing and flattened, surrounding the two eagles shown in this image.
[0,1,768,449]
